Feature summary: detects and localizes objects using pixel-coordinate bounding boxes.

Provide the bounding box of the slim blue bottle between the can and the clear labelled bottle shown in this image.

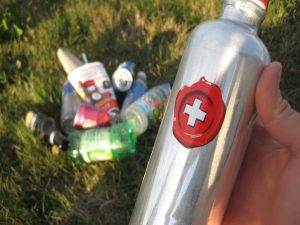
[121,71,148,120]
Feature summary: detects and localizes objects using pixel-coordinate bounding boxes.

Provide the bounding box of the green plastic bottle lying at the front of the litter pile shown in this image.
[68,123,136,163]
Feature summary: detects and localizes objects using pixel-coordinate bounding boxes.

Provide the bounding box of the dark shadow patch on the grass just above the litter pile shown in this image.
[86,19,180,87]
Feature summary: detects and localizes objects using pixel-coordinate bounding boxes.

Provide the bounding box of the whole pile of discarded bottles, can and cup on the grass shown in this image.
[25,48,171,162]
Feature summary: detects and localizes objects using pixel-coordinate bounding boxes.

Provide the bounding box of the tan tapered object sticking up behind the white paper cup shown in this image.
[57,48,84,74]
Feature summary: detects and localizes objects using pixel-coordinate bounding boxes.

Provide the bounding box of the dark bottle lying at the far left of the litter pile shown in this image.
[25,111,68,150]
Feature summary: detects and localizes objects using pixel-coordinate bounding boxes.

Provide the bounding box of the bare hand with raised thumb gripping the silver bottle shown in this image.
[222,62,300,225]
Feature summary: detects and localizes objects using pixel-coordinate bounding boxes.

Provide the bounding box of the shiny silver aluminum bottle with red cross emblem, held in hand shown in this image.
[130,0,270,225]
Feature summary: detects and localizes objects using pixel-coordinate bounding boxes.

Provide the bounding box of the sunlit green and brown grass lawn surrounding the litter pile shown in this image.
[0,0,300,225]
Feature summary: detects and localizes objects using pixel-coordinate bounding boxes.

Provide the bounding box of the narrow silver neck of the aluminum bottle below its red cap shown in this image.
[221,0,266,32]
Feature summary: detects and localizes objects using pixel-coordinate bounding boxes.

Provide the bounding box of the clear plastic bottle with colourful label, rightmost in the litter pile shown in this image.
[125,83,171,135]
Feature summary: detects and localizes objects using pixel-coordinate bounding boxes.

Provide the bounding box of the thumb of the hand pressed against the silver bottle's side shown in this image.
[256,62,300,156]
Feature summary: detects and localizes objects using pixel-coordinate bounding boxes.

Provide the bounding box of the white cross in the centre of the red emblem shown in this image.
[184,98,207,127]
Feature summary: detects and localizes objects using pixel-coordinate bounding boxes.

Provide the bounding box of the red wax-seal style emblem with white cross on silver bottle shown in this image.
[173,77,225,148]
